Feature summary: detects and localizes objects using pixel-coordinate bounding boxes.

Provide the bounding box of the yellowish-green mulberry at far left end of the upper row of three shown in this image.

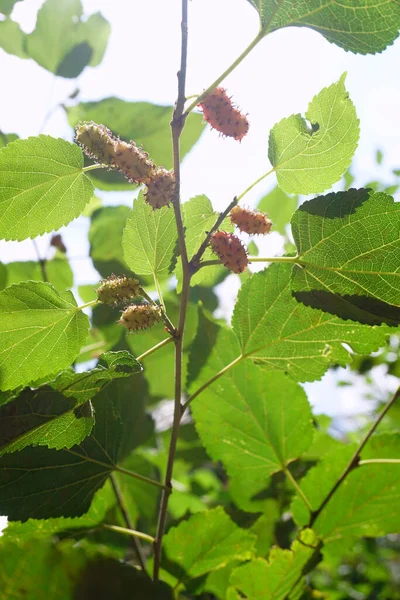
[75,121,116,165]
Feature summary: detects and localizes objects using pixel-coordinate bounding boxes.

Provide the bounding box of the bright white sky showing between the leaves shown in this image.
[0,0,400,415]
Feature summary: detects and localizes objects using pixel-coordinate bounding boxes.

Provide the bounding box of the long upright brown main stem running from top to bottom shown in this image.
[153,0,190,581]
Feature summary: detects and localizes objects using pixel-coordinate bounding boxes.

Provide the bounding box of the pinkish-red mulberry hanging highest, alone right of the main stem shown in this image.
[199,87,249,141]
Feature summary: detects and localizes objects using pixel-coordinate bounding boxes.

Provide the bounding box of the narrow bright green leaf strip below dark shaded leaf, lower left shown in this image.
[2,481,116,543]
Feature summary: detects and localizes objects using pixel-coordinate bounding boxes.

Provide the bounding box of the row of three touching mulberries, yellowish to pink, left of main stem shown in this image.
[75,121,175,210]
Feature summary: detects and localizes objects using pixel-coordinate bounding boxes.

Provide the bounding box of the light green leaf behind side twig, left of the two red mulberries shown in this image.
[177,196,234,291]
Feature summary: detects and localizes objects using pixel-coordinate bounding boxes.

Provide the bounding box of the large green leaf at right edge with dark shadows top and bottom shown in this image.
[292,189,400,325]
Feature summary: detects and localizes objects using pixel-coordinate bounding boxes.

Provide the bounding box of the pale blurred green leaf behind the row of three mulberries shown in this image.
[66,97,205,190]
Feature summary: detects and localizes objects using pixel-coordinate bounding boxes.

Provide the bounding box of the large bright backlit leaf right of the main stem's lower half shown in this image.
[192,338,313,494]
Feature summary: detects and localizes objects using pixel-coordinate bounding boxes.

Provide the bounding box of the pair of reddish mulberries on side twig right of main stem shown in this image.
[210,206,272,273]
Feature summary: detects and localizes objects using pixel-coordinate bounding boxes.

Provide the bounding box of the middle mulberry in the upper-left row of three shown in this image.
[112,140,156,183]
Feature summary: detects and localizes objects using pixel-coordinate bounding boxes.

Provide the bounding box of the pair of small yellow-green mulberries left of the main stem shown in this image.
[96,275,161,331]
